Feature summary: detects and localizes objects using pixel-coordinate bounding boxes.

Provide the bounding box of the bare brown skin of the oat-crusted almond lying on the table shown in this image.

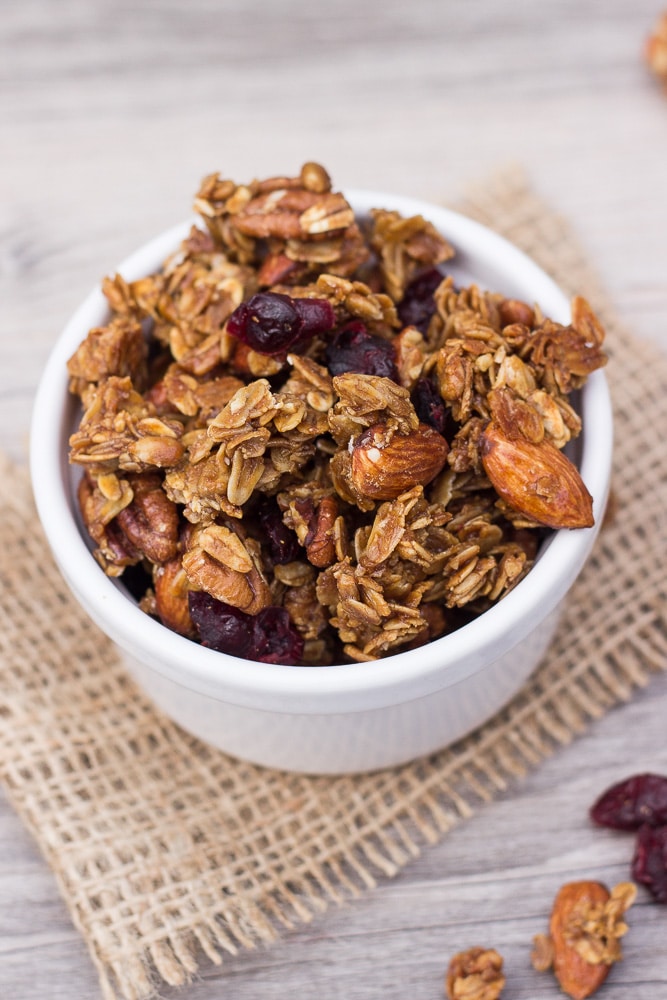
[549,882,611,1000]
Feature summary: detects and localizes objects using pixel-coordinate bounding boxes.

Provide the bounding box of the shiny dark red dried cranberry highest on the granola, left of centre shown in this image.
[227,292,336,354]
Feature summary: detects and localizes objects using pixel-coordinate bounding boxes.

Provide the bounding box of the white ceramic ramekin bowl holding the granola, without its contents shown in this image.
[31,191,612,773]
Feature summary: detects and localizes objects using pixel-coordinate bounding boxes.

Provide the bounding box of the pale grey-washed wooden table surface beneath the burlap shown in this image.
[0,0,667,1000]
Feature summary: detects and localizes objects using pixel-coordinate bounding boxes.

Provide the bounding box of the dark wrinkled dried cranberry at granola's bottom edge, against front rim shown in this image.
[188,591,303,664]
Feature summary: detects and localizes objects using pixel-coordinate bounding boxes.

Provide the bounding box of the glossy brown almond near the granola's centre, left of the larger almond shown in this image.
[351,424,449,500]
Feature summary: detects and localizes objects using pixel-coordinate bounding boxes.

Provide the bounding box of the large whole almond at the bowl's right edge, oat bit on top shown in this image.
[480,421,594,528]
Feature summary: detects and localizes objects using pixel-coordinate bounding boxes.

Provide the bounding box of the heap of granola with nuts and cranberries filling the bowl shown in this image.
[68,163,605,665]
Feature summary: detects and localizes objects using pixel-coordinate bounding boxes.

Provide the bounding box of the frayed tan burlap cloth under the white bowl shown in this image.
[0,172,667,1000]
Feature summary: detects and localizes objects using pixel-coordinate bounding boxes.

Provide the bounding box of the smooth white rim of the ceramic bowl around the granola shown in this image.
[30,189,613,715]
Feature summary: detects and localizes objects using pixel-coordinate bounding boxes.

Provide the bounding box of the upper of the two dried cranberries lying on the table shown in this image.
[590,774,667,830]
